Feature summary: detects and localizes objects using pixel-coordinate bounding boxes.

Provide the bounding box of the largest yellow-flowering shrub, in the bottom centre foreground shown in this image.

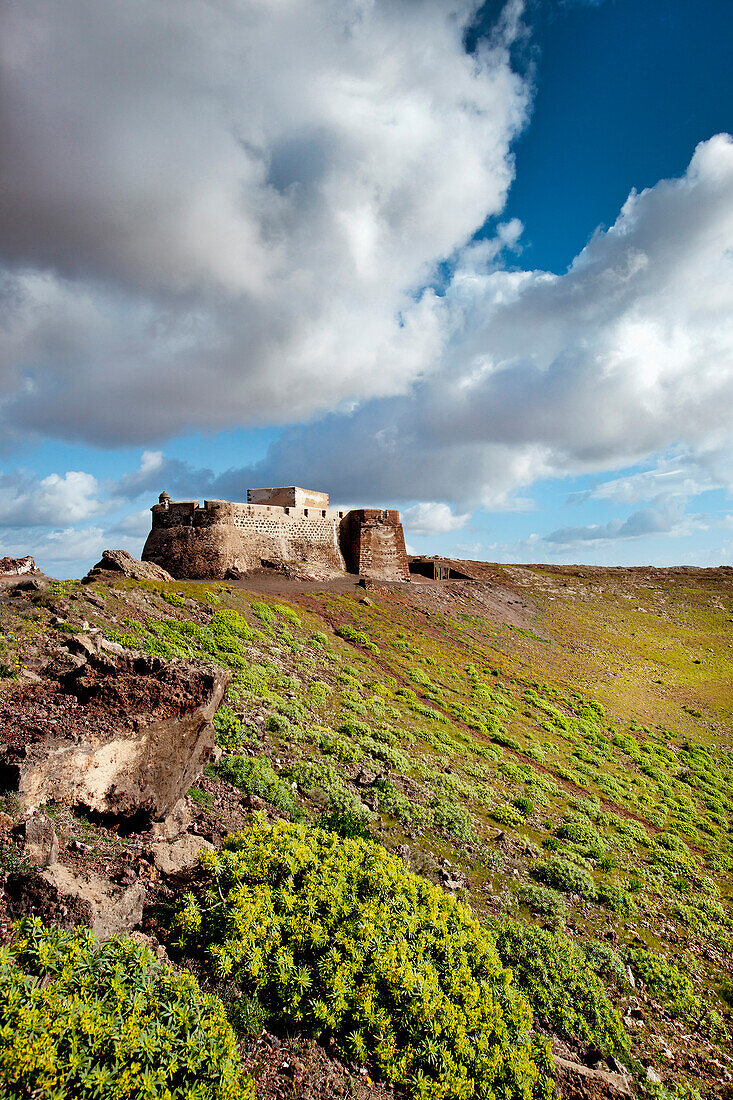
[175,822,553,1100]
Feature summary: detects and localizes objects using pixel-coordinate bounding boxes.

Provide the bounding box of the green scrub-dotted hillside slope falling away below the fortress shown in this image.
[0,562,733,1097]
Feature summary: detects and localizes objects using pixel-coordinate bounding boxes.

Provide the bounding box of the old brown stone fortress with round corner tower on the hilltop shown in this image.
[142,485,409,581]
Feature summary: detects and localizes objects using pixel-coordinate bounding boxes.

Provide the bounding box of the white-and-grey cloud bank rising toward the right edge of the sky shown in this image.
[229,135,733,508]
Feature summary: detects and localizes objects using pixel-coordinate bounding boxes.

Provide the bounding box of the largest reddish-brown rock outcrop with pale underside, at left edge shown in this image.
[0,635,230,820]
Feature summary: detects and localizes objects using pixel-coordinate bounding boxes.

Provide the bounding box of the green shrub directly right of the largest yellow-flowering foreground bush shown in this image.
[493,921,628,1054]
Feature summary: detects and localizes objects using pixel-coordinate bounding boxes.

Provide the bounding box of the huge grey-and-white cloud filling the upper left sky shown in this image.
[0,0,528,444]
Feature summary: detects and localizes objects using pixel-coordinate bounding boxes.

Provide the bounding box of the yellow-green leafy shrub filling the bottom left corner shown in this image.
[0,917,254,1100]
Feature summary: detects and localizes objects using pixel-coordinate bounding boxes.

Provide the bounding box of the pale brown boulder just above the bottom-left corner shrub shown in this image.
[6,864,145,938]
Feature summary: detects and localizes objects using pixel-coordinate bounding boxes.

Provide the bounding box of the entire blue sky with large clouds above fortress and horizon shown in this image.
[0,0,733,576]
